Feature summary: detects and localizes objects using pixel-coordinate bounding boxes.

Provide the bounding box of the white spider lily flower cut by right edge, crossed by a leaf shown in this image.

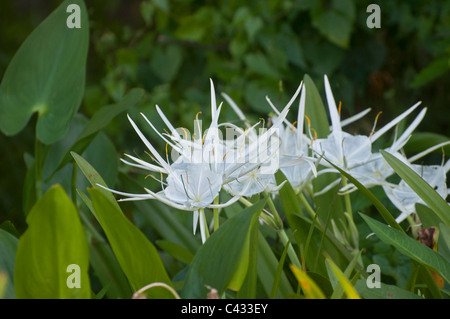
[383,160,450,223]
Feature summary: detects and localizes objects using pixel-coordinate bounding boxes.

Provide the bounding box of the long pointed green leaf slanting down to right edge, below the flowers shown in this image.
[361,214,450,282]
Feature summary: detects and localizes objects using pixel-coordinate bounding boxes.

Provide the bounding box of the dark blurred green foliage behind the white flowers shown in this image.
[0,0,450,248]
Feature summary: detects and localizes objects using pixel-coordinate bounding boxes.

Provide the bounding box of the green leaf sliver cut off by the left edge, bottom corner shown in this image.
[0,229,19,299]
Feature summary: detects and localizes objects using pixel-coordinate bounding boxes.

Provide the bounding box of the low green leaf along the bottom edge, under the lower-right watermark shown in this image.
[355,279,422,299]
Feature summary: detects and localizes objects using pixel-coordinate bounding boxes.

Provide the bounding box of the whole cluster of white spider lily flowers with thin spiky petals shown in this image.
[103,76,450,242]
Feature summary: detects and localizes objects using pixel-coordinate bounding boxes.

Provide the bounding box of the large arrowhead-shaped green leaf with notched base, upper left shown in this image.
[0,0,89,144]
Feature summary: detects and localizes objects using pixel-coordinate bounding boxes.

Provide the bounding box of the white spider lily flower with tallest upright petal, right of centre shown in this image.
[312,75,421,169]
